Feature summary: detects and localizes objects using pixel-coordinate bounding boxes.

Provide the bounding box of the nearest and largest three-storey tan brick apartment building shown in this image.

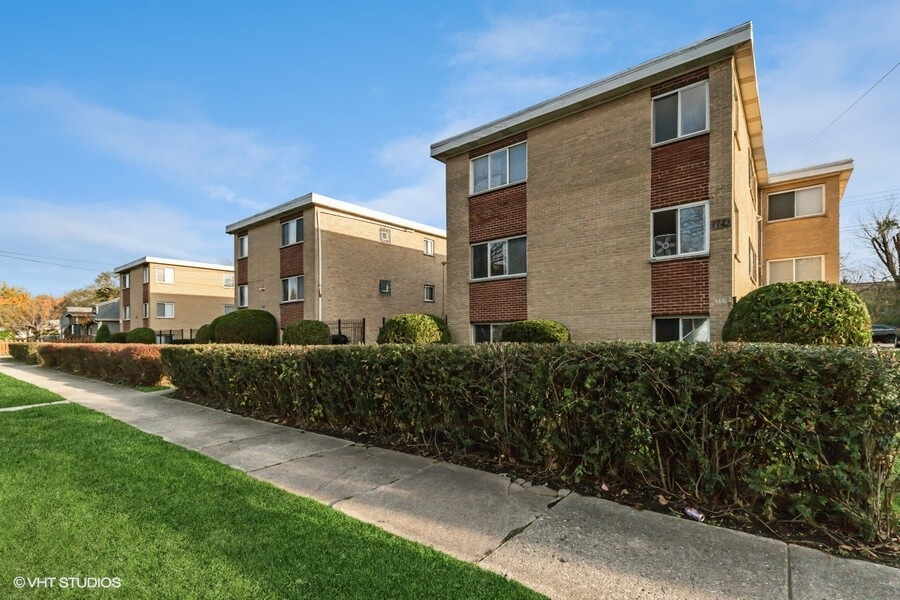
[431,23,853,342]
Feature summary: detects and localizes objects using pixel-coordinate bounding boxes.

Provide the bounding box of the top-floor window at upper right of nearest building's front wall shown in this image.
[653,81,709,144]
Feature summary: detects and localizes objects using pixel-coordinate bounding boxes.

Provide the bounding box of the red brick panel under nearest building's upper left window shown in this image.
[469,183,526,244]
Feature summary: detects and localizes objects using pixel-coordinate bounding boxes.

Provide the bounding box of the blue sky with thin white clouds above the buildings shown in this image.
[0,0,900,295]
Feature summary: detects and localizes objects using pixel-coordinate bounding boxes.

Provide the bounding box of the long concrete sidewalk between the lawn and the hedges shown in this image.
[0,360,900,600]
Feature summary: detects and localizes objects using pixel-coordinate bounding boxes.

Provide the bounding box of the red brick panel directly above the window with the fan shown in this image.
[650,134,709,209]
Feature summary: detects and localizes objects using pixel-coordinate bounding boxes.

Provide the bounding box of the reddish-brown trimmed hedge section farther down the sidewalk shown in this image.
[37,344,163,386]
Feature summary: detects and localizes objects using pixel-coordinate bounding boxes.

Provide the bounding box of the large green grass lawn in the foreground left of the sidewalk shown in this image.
[0,400,540,599]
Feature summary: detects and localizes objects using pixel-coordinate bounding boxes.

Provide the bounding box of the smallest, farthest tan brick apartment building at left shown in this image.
[115,256,235,342]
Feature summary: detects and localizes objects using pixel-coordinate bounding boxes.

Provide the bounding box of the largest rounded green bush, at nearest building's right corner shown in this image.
[722,281,872,346]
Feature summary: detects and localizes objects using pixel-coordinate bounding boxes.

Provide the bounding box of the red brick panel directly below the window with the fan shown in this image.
[650,256,709,316]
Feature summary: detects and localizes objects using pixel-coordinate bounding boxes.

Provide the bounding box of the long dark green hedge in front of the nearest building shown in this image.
[162,342,900,540]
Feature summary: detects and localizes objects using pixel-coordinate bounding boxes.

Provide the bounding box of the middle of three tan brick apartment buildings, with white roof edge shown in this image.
[225,194,447,343]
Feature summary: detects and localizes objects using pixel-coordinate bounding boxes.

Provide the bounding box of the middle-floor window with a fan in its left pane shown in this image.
[652,202,709,258]
